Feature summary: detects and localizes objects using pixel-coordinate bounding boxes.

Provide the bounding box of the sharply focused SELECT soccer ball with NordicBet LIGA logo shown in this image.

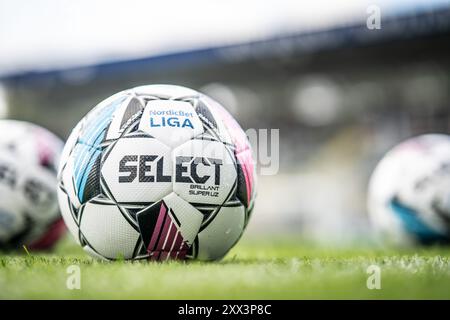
[58,85,256,261]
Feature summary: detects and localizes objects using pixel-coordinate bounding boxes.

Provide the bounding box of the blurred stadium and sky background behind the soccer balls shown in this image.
[0,0,450,243]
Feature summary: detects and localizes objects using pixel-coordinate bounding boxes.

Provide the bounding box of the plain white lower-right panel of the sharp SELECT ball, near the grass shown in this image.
[197,206,245,260]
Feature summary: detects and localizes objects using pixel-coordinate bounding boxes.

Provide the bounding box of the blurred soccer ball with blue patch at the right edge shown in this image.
[368,134,450,245]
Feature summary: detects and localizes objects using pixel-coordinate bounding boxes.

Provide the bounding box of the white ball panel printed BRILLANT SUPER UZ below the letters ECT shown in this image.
[172,139,236,205]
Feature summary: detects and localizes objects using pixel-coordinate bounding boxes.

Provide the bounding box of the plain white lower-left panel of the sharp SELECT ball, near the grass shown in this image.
[80,202,139,259]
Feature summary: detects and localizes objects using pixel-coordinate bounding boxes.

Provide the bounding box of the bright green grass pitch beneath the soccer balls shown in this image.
[0,238,450,299]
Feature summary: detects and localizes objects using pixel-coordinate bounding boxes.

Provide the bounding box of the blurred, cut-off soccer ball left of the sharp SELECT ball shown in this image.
[0,120,65,250]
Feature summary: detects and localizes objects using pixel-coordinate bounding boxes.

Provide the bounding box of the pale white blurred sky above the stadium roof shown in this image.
[0,0,450,75]
